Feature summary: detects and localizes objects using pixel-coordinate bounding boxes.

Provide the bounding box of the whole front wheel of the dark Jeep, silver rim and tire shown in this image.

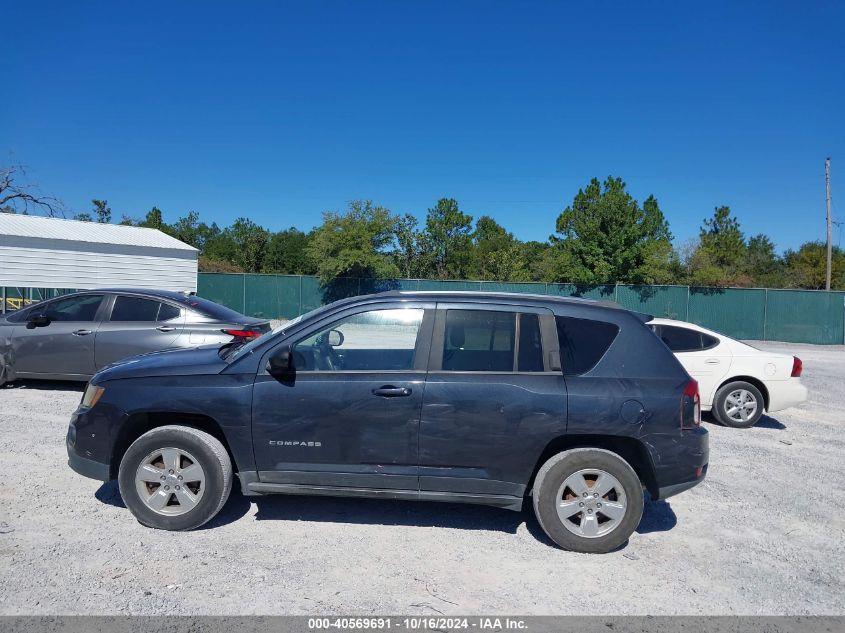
[118,426,232,530]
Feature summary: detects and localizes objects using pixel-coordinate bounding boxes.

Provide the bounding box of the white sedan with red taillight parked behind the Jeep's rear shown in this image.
[648,319,807,429]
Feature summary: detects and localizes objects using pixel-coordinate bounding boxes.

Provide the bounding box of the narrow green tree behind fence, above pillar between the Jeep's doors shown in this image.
[424,198,472,279]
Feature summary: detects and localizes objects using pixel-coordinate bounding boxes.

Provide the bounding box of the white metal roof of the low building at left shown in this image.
[0,213,197,251]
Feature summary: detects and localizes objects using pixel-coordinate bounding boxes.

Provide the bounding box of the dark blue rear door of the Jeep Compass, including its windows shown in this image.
[419,303,567,498]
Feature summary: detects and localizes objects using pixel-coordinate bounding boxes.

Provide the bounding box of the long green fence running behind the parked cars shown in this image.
[198,273,845,345]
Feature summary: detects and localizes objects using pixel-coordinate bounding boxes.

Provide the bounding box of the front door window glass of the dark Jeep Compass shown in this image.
[293,308,424,371]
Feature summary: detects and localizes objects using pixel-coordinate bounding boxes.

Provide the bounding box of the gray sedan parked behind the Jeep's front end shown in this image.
[0,288,270,385]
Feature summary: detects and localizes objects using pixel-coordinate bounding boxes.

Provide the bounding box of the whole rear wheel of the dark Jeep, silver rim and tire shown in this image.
[533,448,643,554]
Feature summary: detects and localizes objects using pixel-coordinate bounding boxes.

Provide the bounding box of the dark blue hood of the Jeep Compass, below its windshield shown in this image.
[91,345,226,384]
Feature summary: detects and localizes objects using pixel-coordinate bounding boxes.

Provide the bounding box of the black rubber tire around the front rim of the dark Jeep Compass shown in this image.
[118,425,232,530]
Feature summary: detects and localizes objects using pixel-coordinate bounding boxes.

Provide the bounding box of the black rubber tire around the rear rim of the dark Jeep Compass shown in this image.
[532,448,643,554]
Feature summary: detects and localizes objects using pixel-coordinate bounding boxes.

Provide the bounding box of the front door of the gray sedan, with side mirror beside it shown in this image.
[12,294,103,378]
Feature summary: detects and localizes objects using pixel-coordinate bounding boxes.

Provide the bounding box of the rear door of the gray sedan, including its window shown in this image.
[94,295,185,369]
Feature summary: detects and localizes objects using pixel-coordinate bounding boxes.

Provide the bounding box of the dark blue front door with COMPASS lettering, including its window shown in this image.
[252,304,433,491]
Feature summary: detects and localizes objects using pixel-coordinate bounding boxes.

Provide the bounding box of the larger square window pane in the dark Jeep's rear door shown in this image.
[442,310,516,371]
